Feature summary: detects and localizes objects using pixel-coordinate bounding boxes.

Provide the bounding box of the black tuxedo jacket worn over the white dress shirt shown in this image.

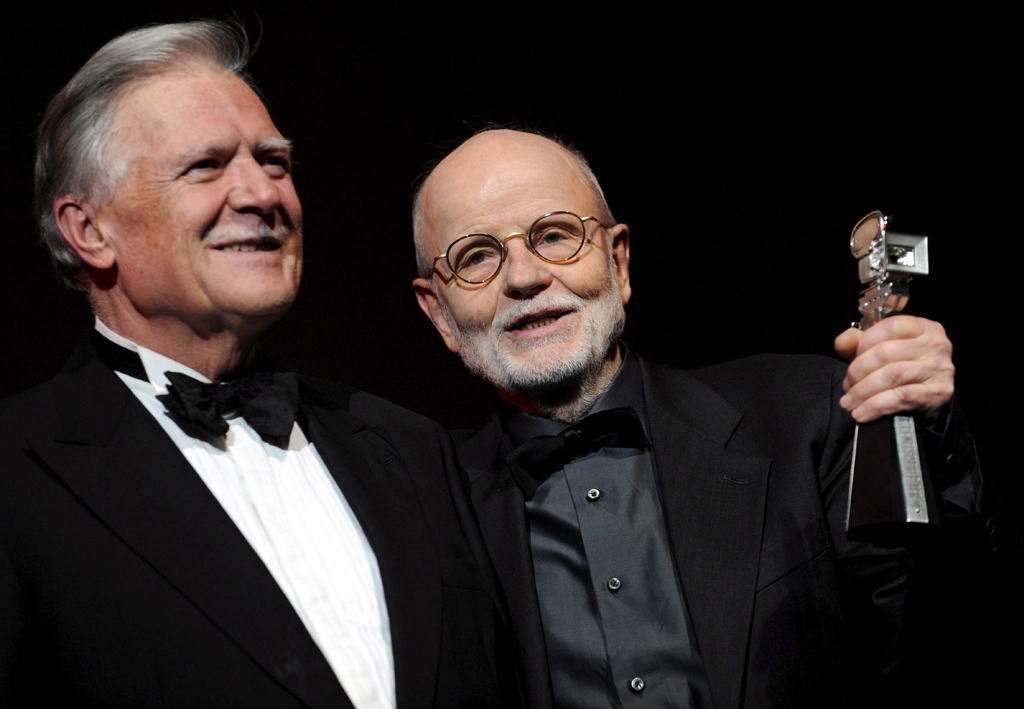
[0,342,519,708]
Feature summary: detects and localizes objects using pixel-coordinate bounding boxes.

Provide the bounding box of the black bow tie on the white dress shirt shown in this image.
[157,371,299,440]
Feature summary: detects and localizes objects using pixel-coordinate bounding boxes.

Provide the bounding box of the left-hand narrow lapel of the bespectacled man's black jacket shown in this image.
[459,415,552,707]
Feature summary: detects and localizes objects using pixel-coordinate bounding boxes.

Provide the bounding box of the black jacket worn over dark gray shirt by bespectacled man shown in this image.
[458,356,937,709]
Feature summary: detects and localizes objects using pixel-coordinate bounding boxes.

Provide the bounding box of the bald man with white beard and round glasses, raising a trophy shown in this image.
[414,130,977,709]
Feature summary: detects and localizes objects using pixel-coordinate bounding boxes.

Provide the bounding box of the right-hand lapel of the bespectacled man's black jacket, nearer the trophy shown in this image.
[641,360,770,706]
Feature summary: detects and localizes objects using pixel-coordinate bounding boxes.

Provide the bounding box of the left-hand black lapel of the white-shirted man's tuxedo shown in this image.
[29,350,351,707]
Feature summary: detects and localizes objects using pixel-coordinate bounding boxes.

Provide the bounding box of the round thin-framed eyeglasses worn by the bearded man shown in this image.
[434,212,604,285]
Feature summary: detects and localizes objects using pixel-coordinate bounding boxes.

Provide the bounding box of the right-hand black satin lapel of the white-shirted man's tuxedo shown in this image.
[306,406,442,707]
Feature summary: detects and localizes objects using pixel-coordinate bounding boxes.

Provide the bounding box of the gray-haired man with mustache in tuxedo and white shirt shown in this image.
[0,22,519,709]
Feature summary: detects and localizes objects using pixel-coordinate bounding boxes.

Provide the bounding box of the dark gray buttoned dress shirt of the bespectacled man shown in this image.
[503,352,712,709]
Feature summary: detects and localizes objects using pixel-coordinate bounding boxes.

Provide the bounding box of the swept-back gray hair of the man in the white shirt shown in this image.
[34,20,255,289]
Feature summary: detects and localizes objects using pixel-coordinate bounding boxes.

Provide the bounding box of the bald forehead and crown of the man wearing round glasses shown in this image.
[420,131,598,249]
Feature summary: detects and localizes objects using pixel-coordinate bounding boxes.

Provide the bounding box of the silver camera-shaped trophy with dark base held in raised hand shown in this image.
[846,212,938,541]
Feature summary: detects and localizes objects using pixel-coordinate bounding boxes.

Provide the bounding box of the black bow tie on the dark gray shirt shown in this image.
[505,407,649,500]
